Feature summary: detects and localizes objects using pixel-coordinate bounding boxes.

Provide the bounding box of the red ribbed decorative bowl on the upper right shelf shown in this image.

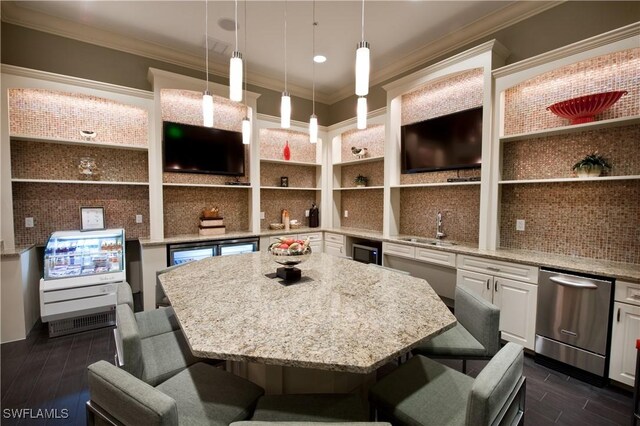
[547,90,627,124]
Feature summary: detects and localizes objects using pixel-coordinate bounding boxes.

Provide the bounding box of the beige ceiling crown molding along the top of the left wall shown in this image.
[2,1,329,103]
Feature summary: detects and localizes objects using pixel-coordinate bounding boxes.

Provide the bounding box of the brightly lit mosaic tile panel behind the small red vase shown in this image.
[259,129,317,163]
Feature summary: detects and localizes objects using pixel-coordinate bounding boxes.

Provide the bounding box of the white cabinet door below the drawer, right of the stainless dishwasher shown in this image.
[609,302,640,386]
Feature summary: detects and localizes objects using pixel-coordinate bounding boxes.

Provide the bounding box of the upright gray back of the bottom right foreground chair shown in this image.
[466,342,524,426]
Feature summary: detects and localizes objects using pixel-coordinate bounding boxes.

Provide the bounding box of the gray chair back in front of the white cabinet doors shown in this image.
[455,286,500,357]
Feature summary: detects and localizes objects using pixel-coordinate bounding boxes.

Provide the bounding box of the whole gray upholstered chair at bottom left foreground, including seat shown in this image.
[87,361,264,426]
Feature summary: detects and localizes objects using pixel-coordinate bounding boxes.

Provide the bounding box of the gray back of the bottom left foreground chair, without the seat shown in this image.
[87,361,178,426]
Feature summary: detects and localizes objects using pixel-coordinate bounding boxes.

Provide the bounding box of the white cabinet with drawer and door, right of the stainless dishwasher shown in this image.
[609,281,640,386]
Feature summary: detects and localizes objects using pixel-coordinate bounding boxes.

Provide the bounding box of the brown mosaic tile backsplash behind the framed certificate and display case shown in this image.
[12,182,149,246]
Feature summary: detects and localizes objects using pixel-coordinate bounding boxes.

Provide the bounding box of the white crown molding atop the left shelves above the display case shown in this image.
[0,64,153,99]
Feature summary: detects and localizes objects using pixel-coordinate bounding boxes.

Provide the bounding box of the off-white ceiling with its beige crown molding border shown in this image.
[2,0,557,103]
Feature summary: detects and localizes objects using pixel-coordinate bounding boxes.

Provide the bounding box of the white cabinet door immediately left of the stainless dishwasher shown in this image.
[493,277,538,350]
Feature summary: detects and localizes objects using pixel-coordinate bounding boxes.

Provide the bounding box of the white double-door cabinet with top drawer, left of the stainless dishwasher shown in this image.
[456,255,538,350]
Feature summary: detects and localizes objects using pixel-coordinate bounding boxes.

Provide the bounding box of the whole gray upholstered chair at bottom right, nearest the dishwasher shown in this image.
[369,343,525,426]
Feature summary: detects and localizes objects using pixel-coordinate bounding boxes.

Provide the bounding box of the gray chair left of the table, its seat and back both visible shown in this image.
[115,304,200,386]
